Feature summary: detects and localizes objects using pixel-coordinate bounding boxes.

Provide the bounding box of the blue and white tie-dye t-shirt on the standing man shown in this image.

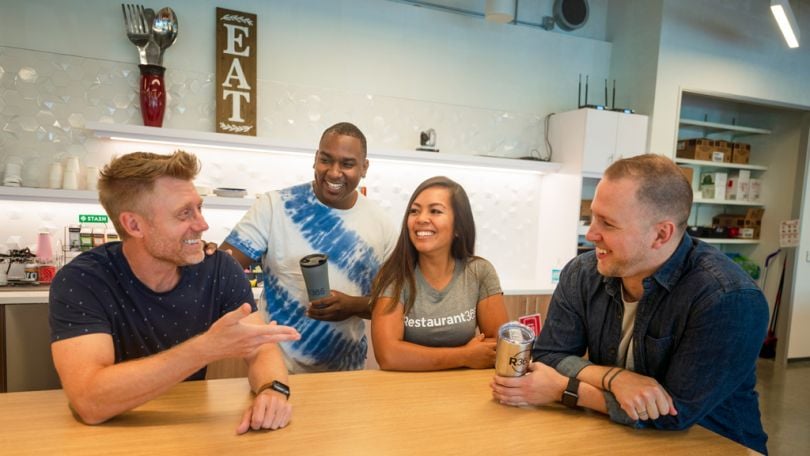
[225,182,396,372]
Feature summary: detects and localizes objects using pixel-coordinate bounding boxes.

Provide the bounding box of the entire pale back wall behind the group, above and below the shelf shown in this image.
[0,0,611,288]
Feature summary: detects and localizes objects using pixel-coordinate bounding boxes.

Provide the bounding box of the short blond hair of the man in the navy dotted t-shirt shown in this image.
[98,150,200,239]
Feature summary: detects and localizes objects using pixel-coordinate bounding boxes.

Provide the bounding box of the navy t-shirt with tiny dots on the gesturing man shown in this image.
[49,242,256,380]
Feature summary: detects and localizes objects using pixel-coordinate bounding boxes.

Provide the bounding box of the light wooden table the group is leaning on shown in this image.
[0,370,750,456]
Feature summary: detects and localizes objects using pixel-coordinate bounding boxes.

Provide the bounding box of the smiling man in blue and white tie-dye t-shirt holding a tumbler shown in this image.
[221,122,396,372]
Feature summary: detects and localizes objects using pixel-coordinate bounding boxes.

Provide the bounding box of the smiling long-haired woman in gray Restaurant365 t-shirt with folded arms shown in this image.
[371,176,508,371]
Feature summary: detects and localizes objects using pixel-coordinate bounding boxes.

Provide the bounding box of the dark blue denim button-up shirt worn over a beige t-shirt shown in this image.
[532,235,768,453]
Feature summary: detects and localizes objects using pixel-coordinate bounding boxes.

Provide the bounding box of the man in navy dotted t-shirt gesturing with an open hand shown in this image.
[49,151,300,433]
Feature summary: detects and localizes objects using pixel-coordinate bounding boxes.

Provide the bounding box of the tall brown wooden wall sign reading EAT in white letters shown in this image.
[216,8,258,136]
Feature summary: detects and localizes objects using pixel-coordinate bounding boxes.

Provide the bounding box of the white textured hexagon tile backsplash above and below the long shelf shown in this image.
[0,47,577,284]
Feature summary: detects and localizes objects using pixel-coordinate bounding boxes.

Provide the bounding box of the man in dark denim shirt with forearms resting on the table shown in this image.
[491,155,768,453]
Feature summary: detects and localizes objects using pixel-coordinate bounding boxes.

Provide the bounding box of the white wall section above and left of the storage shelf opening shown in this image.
[650,0,810,157]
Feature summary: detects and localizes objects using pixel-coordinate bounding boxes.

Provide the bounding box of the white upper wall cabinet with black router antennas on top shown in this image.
[548,108,648,177]
